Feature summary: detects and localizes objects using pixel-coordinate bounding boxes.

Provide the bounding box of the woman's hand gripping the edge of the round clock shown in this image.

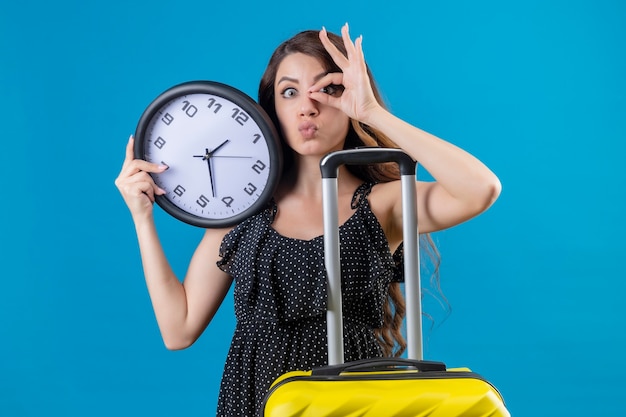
[115,136,168,220]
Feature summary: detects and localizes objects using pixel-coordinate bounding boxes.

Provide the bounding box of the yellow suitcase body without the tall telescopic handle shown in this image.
[264,359,510,417]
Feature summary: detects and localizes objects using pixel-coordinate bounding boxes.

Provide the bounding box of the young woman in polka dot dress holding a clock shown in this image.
[116,25,500,416]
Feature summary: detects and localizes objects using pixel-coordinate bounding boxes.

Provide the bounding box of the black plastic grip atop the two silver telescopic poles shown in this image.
[320,146,416,178]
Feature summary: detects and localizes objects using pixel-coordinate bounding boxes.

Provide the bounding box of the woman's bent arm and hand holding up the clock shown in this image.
[115,138,232,349]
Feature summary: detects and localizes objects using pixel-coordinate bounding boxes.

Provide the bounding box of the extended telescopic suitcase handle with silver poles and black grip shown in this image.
[320,147,423,365]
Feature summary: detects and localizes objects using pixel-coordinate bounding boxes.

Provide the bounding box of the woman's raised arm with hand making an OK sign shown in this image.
[309,25,501,238]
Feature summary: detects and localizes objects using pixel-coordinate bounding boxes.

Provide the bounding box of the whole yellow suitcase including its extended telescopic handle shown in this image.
[263,148,510,417]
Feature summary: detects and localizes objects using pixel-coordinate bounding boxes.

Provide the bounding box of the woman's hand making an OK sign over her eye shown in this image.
[309,23,380,123]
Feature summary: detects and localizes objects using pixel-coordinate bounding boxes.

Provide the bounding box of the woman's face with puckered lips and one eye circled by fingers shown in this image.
[274,53,350,155]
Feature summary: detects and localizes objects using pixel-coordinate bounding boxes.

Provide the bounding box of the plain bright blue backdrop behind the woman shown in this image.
[0,0,626,417]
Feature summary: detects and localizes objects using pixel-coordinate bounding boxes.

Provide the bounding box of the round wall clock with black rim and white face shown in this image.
[134,81,282,228]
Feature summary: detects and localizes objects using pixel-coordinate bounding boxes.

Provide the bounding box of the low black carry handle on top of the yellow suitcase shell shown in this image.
[311,358,446,376]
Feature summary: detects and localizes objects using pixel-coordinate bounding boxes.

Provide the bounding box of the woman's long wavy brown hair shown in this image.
[259,30,439,356]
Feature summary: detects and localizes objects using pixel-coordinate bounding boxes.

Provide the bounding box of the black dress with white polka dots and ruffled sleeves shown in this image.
[217,184,402,417]
